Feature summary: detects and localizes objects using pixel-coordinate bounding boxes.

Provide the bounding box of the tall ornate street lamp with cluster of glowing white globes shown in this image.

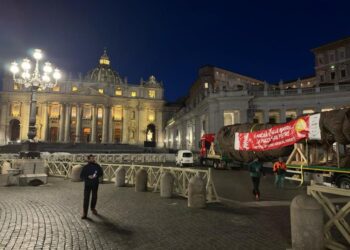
[10,49,61,158]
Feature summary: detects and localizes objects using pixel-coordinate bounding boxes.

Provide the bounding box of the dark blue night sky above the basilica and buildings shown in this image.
[0,0,350,101]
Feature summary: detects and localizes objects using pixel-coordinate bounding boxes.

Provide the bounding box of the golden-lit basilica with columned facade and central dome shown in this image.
[0,51,164,146]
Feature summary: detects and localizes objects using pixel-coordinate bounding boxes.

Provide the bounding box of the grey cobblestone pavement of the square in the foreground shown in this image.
[0,171,299,250]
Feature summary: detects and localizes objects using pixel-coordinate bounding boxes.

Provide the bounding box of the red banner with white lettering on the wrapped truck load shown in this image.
[235,116,309,151]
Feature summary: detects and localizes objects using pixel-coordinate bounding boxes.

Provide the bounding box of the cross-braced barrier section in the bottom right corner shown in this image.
[307,183,350,250]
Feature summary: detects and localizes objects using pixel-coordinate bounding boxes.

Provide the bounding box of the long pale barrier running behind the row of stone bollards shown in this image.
[46,160,219,202]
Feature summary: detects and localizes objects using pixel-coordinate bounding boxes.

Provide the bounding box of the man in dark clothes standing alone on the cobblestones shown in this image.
[80,155,103,219]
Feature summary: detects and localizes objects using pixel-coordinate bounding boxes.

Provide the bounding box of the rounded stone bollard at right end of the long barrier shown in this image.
[188,175,206,208]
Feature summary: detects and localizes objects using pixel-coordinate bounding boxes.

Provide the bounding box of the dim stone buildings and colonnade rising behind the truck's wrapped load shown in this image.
[164,37,350,150]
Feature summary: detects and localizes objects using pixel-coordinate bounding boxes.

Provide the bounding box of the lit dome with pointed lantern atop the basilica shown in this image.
[85,50,121,84]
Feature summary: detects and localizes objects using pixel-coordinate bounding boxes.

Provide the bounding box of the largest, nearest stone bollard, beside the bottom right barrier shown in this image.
[290,195,324,250]
